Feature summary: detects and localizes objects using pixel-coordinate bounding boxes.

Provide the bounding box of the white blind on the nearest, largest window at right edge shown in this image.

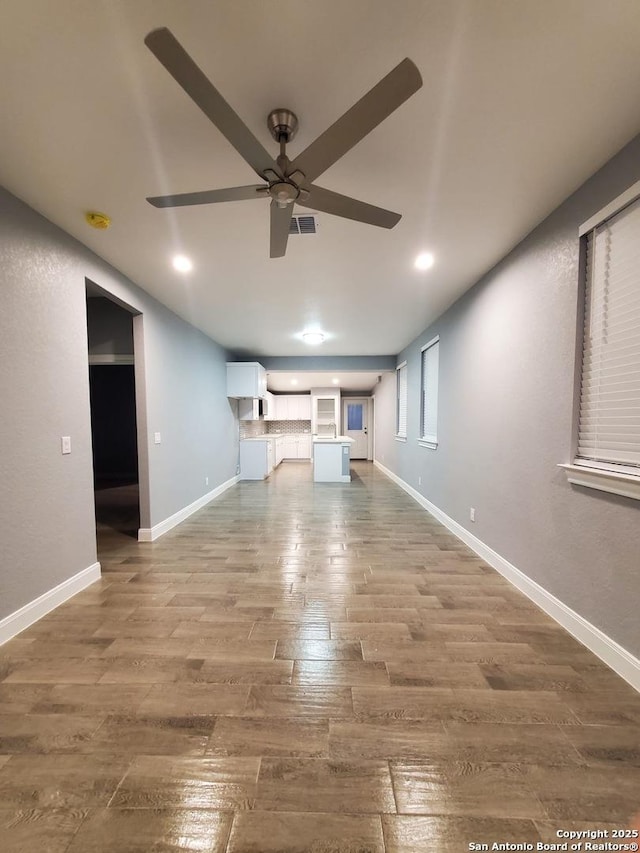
[578,200,640,475]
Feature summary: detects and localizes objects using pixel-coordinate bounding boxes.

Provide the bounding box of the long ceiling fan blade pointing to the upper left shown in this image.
[144,27,279,177]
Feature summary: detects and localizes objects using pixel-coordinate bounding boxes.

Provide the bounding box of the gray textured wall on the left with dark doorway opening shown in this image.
[0,190,238,619]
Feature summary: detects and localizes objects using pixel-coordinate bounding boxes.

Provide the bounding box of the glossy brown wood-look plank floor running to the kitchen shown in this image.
[0,463,640,853]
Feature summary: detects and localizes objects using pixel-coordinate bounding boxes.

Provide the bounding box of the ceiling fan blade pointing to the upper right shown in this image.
[293,59,422,183]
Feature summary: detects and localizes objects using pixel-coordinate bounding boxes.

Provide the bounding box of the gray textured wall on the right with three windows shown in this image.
[375,137,640,656]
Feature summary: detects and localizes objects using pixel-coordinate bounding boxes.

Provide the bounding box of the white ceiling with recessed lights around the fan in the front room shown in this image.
[0,0,640,356]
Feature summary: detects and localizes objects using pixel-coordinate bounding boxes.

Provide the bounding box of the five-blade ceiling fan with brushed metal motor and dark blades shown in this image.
[144,27,422,258]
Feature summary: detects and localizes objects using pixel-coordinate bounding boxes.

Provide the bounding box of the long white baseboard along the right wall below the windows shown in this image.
[373,460,640,691]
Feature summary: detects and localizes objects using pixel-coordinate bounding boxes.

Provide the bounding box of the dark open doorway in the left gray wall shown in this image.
[87,282,140,558]
